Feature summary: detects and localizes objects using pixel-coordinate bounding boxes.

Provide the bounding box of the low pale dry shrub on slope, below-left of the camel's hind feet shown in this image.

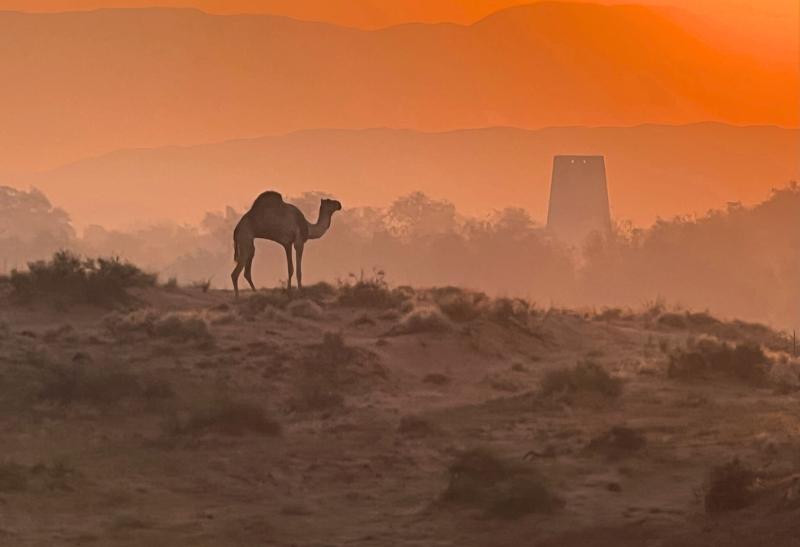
[104,310,213,342]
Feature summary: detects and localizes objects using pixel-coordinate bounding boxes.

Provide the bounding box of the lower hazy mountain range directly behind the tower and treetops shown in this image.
[14,123,800,226]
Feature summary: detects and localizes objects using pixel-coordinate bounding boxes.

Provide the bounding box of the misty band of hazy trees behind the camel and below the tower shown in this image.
[0,184,800,330]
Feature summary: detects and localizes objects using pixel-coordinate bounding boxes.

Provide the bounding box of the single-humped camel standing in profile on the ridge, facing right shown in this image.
[231,191,342,298]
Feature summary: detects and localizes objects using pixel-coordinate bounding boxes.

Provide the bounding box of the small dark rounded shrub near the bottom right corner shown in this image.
[705,459,756,513]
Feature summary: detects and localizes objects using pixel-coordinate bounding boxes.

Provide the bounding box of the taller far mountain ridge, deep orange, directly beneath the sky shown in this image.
[0,2,799,170]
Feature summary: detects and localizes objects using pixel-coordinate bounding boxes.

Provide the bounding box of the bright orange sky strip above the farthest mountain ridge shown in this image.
[0,0,800,62]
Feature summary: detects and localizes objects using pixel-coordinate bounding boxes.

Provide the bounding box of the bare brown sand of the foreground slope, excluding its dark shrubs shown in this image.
[0,289,800,547]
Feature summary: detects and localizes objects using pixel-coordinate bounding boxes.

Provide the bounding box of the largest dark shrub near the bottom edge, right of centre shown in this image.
[442,449,563,518]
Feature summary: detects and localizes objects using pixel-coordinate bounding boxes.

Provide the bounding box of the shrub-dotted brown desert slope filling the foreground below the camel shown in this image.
[0,258,800,546]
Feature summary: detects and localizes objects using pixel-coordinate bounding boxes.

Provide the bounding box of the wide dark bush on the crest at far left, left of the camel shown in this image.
[10,251,156,306]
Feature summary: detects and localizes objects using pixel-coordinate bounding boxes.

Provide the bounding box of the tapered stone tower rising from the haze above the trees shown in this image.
[547,156,611,244]
